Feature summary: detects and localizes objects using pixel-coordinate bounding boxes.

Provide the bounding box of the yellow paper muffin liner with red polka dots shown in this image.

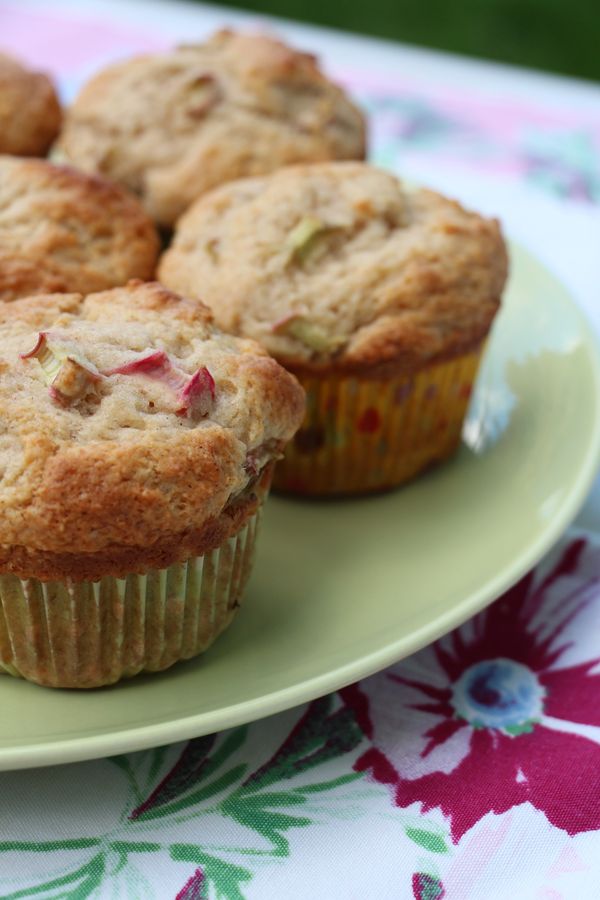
[273,347,483,496]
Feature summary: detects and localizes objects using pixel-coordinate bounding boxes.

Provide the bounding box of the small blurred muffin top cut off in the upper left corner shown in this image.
[0,53,61,156]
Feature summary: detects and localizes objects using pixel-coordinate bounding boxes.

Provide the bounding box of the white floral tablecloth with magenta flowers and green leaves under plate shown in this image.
[0,0,600,900]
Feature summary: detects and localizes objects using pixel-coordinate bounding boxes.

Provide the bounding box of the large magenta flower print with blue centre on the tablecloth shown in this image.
[343,540,600,842]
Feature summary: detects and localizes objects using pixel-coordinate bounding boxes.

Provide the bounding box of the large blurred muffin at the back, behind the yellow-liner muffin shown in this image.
[59,31,365,226]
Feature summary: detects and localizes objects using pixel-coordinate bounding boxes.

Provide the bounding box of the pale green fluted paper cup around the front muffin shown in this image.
[0,508,260,688]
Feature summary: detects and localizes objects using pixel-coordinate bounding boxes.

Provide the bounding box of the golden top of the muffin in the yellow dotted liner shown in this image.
[159,162,507,375]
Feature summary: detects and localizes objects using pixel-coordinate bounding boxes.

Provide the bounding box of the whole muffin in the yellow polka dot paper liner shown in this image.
[159,162,507,495]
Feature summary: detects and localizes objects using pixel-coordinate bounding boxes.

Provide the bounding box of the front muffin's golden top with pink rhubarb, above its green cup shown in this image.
[0,281,304,578]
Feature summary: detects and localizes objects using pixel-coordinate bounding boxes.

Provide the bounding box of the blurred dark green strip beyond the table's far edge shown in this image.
[207,0,600,81]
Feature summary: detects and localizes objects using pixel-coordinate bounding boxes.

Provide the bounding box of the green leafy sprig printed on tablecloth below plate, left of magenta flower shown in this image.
[0,695,362,900]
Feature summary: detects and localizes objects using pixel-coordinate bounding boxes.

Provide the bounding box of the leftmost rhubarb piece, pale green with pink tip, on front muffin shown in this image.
[21,331,102,406]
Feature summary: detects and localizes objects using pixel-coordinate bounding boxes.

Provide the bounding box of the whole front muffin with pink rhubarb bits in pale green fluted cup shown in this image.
[0,282,304,688]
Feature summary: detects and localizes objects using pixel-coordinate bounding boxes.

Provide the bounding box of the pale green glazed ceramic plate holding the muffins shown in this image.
[0,243,600,769]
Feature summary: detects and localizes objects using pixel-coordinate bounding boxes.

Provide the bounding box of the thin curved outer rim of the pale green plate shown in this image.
[0,241,600,771]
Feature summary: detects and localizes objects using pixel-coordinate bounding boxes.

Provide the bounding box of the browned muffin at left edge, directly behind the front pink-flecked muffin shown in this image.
[0,156,159,301]
